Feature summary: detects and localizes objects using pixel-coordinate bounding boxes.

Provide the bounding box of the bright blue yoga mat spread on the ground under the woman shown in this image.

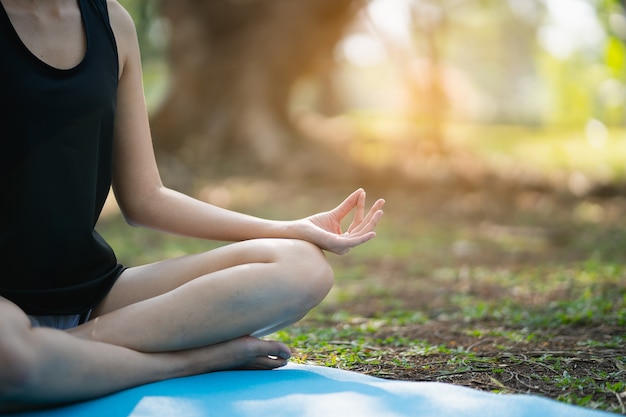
[7,364,616,417]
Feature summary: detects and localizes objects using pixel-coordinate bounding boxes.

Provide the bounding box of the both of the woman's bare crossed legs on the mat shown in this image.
[0,240,333,413]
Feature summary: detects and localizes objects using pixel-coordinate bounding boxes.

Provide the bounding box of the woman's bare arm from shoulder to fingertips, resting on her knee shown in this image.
[109,1,384,253]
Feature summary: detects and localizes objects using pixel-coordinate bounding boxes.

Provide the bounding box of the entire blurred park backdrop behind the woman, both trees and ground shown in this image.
[101,0,626,406]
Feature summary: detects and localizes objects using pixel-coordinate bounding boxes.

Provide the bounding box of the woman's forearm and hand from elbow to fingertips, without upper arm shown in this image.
[118,186,385,254]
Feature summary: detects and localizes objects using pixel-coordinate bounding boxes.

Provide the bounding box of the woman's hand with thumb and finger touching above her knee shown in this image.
[297,189,385,255]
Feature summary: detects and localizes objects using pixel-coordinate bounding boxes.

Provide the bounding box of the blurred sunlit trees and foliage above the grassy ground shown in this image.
[117,0,626,195]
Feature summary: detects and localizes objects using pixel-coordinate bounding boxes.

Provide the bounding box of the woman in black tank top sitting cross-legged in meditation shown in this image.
[0,0,384,411]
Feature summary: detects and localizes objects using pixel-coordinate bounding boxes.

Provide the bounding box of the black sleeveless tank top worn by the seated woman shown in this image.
[0,0,123,314]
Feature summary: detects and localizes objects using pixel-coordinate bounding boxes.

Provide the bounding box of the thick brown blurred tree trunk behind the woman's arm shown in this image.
[152,0,362,177]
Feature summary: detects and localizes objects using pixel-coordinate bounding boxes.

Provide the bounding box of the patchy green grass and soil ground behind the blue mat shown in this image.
[99,123,626,414]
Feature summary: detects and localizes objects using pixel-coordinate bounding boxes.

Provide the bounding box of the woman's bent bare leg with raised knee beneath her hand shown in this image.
[70,239,333,352]
